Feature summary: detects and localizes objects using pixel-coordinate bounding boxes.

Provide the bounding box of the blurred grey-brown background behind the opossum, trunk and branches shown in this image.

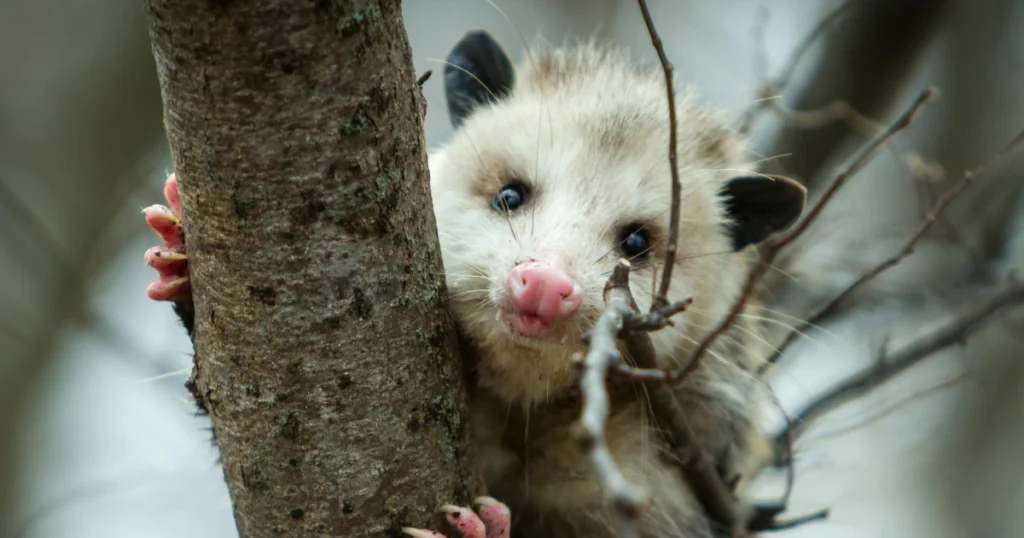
[0,0,1024,538]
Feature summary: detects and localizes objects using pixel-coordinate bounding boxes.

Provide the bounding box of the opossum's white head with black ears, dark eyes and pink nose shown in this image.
[430,32,805,406]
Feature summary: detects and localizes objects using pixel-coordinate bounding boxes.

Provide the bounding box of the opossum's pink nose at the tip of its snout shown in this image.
[508,261,583,322]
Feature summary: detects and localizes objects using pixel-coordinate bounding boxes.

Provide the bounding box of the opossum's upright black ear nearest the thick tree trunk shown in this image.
[444,30,515,127]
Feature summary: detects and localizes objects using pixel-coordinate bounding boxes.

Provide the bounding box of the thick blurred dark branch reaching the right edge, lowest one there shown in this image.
[776,283,1024,443]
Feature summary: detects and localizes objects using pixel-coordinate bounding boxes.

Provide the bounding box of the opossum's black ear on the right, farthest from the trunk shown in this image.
[722,175,807,250]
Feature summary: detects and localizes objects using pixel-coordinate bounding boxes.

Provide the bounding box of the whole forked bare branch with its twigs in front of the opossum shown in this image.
[577,5,935,536]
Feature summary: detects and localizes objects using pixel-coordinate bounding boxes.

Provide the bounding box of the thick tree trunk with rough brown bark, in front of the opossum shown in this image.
[146,0,480,538]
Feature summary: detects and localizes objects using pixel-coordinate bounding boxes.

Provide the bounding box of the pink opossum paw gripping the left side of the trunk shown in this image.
[142,174,191,300]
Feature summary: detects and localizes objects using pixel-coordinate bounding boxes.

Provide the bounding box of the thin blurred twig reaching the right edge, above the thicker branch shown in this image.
[766,130,1024,367]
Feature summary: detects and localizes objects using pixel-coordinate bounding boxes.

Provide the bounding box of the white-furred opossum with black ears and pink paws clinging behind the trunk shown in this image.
[145,31,806,538]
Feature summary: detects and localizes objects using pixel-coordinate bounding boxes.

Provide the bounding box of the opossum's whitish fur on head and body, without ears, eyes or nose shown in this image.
[430,40,763,537]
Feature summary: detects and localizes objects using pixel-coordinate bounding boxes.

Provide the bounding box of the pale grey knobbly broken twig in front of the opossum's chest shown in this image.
[573,259,646,538]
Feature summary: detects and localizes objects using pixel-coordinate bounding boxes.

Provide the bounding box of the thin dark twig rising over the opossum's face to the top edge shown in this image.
[637,0,682,311]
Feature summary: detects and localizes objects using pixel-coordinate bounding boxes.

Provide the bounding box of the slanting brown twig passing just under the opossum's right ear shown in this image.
[671,87,938,382]
